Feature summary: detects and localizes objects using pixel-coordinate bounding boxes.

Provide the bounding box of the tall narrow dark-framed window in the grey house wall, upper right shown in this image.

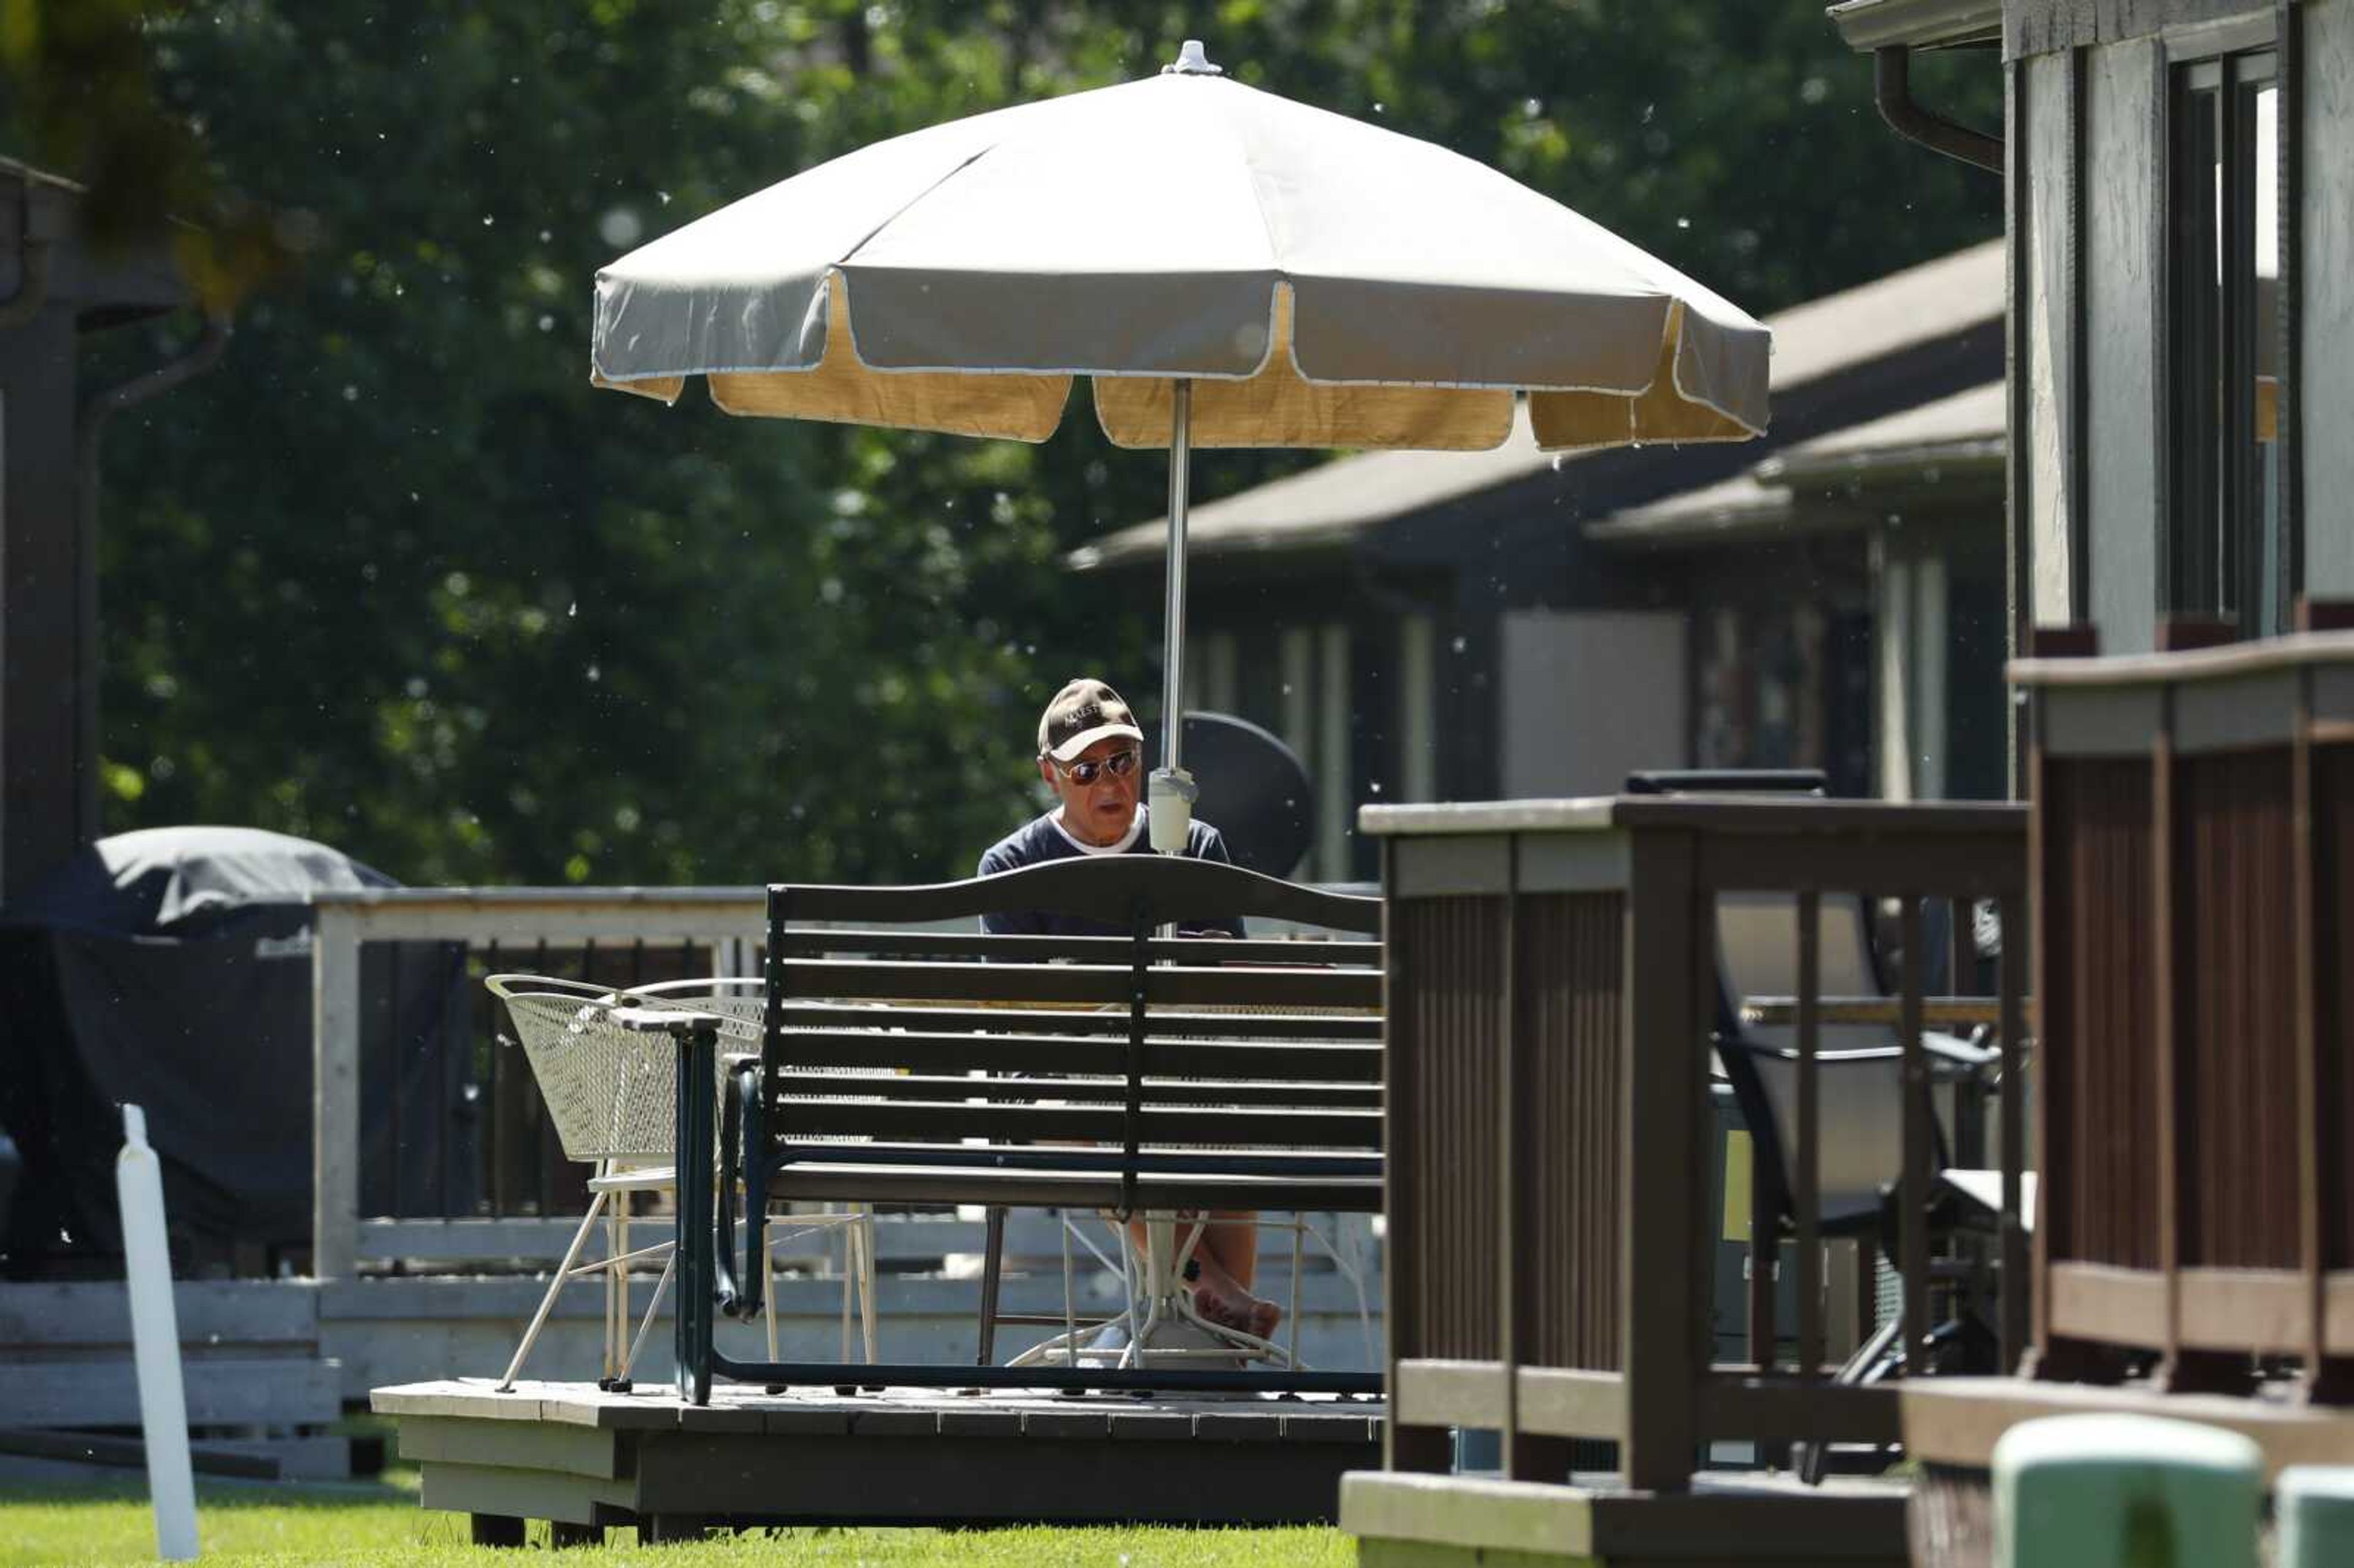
[2163,51,2288,636]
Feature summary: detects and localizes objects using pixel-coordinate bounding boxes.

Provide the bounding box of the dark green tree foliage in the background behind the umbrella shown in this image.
[0,0,1998,883]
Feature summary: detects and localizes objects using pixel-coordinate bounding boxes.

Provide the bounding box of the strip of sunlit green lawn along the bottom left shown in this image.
[0,1479,1356,1568]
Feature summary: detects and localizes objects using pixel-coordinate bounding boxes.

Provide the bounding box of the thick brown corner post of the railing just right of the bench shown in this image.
[1620,829,1707,1490]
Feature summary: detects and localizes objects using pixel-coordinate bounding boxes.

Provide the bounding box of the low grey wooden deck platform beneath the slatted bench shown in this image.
[370,1380,1384,1540]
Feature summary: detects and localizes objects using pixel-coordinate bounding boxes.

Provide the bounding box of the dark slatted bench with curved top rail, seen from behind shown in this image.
[659,854,1382,1403]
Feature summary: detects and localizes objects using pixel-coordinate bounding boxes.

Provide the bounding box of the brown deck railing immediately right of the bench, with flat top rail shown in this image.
[1361,796,2027,1490]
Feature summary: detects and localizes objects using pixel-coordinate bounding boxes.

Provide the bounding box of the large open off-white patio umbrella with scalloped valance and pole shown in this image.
[593,40,1770,850]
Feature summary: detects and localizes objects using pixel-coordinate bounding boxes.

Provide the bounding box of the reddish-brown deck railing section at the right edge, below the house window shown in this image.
[2013,631,2354,1403]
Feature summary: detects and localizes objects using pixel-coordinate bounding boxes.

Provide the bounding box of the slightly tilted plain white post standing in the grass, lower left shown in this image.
[115,1104,196,1563]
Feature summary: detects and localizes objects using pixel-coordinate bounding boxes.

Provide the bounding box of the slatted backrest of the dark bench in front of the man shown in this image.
[763,854,1382,1161]
